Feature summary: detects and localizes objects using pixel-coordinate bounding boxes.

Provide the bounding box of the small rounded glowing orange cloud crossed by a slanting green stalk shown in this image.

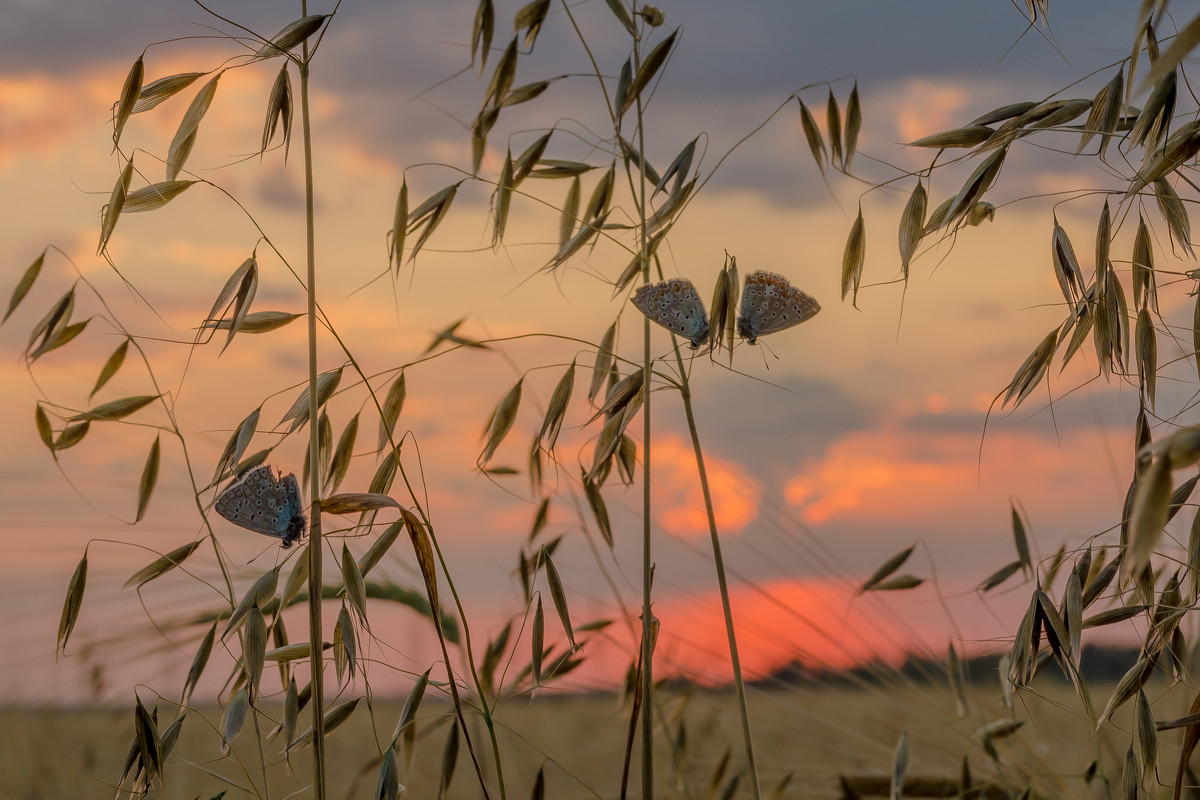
[652,435,762,536]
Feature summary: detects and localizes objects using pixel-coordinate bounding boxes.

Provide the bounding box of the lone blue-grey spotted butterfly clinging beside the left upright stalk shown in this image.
[214,464,308,547]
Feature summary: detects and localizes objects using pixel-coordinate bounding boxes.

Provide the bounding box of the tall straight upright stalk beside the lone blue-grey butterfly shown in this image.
[300,14,325,800]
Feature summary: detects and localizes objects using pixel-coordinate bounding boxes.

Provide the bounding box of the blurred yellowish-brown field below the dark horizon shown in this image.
[0,679,1190,800]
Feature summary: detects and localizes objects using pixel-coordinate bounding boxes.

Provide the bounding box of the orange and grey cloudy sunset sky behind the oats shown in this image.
[0,0,1161,702]
